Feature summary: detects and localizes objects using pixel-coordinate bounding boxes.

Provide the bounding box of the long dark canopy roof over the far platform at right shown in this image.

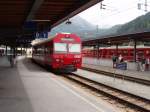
[82,32,150,46]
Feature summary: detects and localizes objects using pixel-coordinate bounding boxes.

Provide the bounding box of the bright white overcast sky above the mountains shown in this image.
[79,0,150,28]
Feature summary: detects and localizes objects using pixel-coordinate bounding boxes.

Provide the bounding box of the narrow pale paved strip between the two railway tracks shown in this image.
[75,69,150,100]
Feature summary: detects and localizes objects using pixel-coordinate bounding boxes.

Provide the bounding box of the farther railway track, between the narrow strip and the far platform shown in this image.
[82,67,150,86]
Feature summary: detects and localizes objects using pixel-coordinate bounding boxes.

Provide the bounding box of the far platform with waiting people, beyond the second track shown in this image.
[82,58,150,81]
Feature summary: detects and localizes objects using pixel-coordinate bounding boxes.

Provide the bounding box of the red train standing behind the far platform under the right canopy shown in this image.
[82,45,150,62]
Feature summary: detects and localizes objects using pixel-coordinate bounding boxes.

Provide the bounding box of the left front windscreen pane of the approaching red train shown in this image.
[54,43,67,53]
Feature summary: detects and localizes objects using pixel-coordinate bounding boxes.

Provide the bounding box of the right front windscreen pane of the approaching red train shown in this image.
[68,44,81,53]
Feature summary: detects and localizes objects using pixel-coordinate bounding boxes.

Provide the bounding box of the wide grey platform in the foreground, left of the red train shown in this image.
[0,57,117,112]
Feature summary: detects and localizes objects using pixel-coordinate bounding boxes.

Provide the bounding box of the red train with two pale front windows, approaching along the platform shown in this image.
[32,33,82,72]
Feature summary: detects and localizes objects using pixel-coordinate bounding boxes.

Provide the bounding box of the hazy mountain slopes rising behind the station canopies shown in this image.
[50,12,150,39]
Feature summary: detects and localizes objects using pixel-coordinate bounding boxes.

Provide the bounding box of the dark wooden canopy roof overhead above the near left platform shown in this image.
[0,0,102,45]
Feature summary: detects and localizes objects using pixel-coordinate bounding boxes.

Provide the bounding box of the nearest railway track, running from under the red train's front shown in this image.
[64,74,150,112]
